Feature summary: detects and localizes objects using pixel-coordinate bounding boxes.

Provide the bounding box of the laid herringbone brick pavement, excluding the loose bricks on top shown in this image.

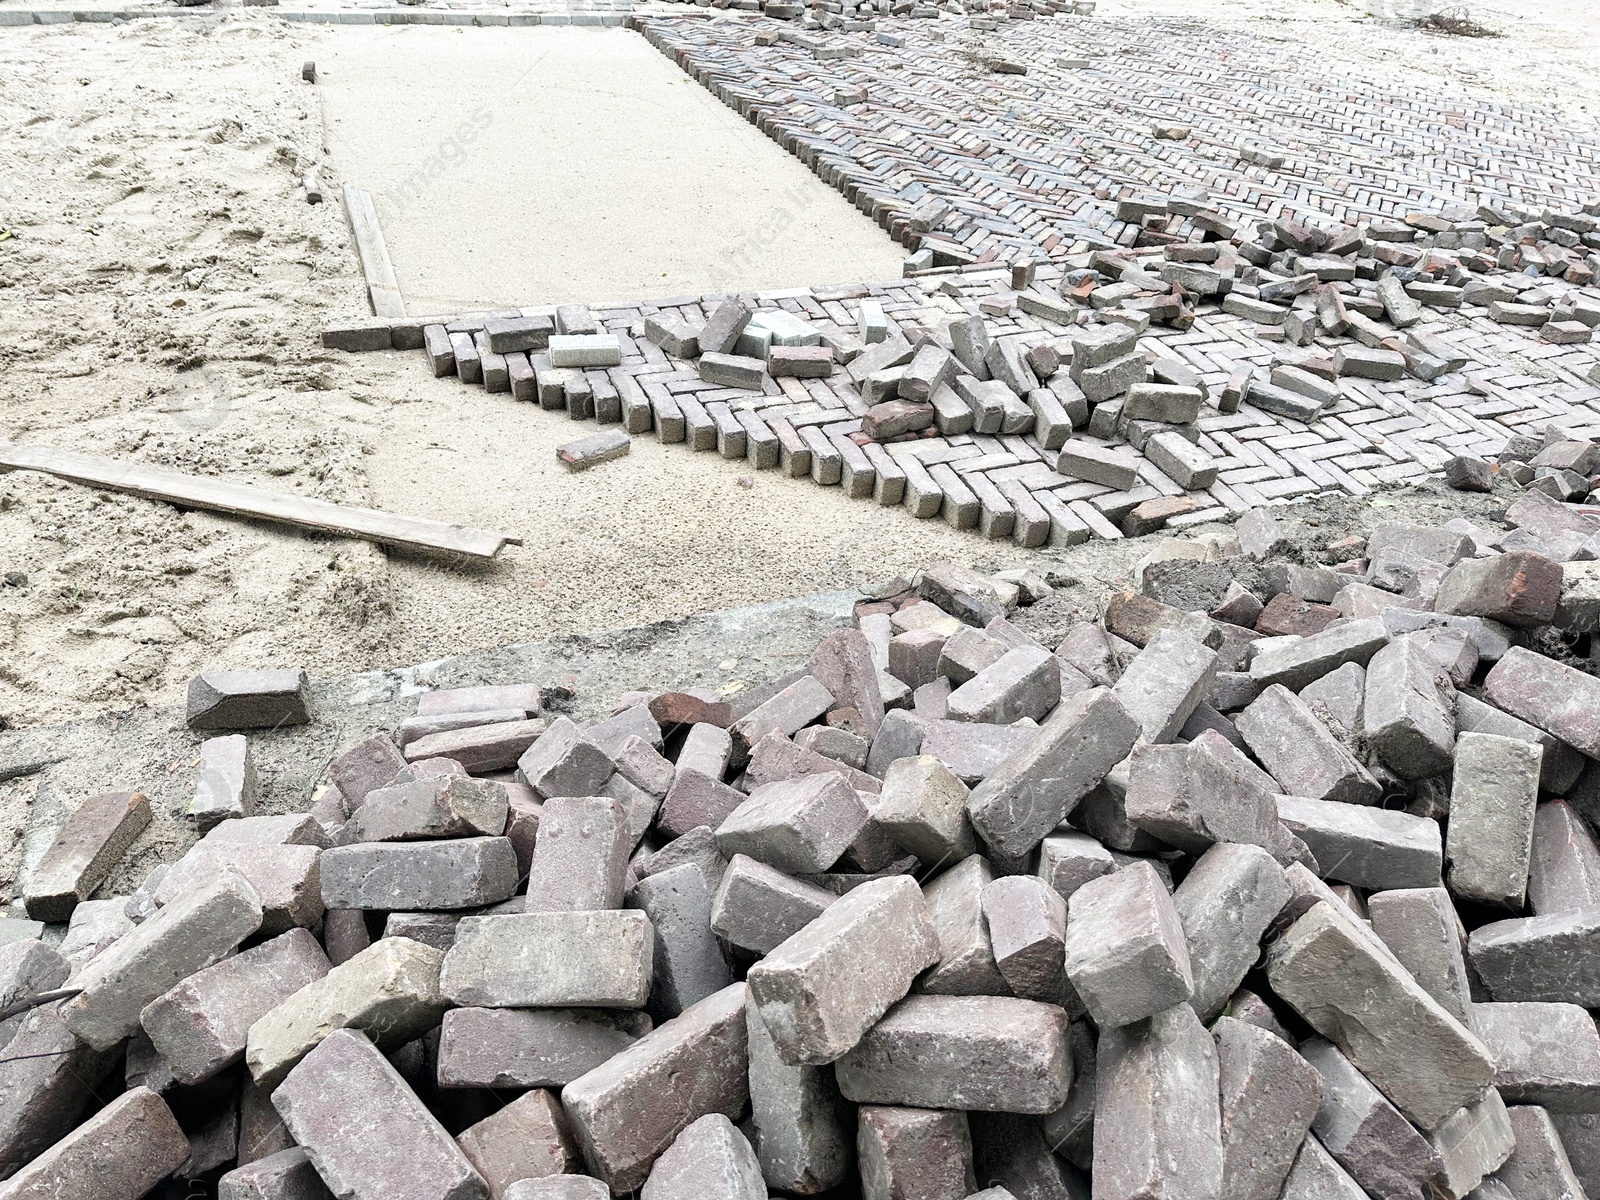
[344,8,1600,546]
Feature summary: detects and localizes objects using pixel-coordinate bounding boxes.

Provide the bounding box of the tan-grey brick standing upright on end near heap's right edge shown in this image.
[1445,733,1544,909]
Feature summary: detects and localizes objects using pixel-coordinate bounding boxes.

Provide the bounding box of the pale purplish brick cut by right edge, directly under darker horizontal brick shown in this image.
[1470,1002,1600,1112]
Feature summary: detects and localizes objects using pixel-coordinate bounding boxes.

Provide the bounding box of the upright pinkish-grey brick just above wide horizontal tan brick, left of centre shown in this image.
[523,795,634,912]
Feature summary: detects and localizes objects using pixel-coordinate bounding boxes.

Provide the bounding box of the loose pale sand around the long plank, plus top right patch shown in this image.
[0,0,1600,725]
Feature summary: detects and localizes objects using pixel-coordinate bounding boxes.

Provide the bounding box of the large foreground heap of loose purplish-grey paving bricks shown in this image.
[9,502,1600,1200]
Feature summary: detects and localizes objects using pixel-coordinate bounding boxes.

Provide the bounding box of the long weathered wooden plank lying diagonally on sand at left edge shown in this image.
[0,445,522,558]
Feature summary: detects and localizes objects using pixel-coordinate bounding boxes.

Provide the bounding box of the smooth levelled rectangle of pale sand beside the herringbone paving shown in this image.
[317,26,901,312]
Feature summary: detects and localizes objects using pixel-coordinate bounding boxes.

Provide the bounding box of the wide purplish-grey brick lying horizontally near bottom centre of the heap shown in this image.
[835,995,1072,1114]
